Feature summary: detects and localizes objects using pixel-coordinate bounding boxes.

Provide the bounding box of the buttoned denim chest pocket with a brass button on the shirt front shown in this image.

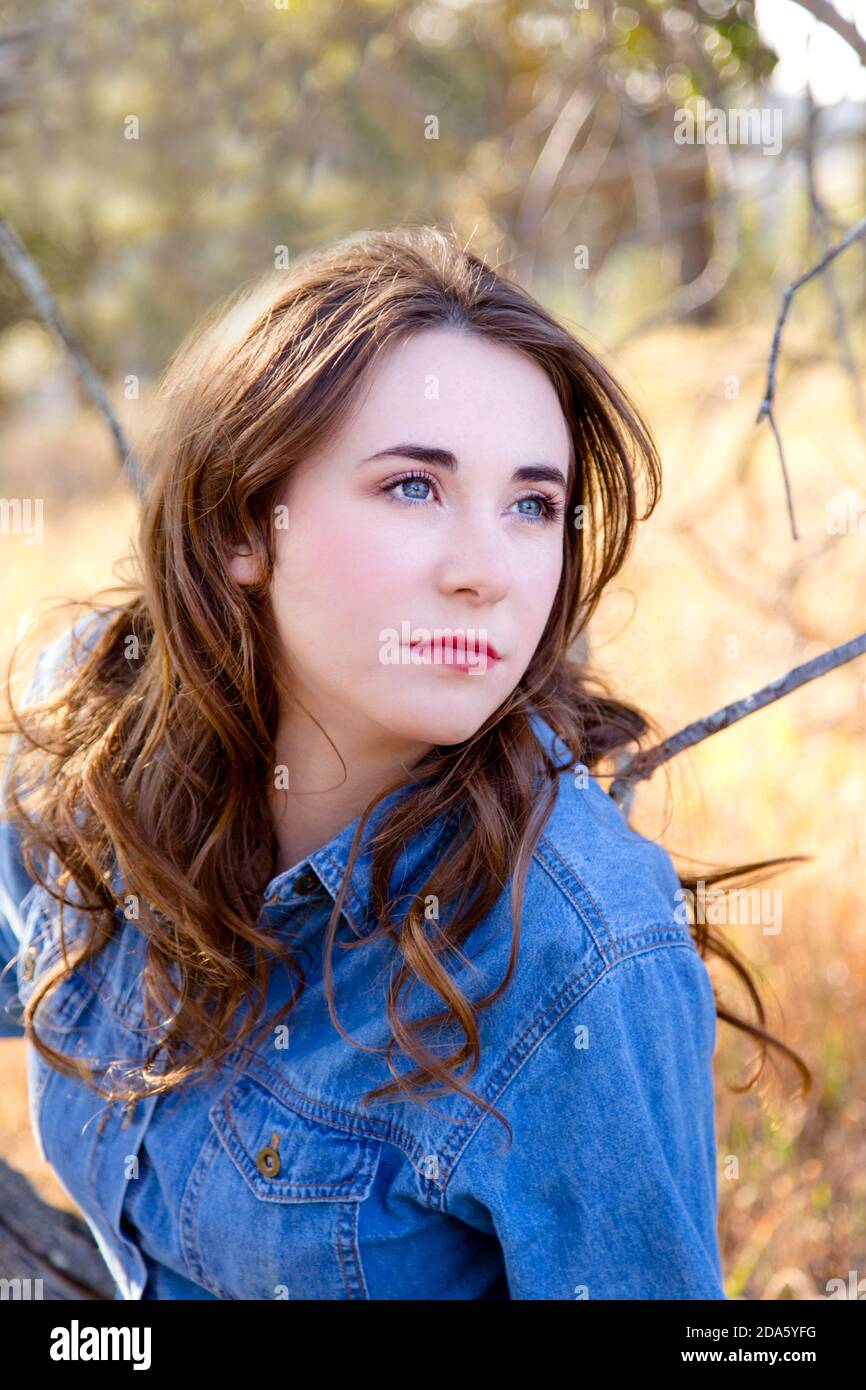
[181,1074,381,1300]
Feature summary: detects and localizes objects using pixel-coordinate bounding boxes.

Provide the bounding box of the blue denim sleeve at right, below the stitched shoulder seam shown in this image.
[446,941,726,1300]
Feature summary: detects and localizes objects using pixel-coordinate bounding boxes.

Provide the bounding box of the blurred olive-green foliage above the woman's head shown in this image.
[0,0,774,377]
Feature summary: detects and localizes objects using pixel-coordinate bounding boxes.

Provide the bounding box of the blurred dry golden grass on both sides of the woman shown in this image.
[0,327,866,1300]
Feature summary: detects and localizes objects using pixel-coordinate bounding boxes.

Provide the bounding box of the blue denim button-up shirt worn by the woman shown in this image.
[0,616,726,1300]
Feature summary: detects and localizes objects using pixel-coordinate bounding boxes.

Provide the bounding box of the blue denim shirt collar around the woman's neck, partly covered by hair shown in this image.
[264,710,573,937]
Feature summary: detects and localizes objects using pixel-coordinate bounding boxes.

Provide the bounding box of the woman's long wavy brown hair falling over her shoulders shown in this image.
[4,227,810,1139]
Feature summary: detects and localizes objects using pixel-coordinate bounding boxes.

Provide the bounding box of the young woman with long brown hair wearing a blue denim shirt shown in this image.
[0,228,811,1300]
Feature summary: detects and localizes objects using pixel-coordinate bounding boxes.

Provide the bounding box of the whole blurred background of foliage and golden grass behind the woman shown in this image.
[0,0,866,1300]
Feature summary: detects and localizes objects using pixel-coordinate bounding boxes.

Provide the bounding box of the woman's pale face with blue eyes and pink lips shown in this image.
[232,328,570,753]
